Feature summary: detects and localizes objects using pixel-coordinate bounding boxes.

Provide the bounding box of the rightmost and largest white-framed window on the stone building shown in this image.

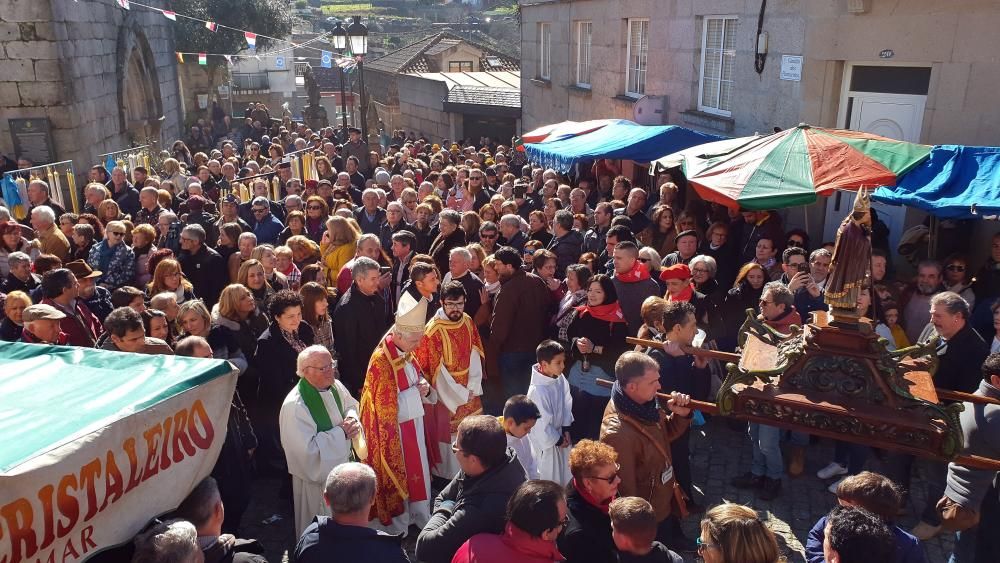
[698,16,737,116]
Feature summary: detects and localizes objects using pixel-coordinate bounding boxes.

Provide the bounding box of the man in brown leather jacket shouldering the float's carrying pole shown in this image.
[601,352,695,551]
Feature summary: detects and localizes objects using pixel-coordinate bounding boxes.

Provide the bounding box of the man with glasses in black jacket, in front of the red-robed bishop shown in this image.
[416,415,525,563]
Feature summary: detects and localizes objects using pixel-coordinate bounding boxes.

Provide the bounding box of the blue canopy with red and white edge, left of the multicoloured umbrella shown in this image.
[524,119,723,172]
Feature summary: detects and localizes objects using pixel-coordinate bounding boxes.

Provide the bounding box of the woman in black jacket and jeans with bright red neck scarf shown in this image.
[566,274,628,442]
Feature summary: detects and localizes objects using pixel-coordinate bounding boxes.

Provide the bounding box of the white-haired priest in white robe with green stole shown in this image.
[278,345,361,537]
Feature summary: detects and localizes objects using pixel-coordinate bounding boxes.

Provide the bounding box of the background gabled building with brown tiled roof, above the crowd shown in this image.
[364,31,520,134]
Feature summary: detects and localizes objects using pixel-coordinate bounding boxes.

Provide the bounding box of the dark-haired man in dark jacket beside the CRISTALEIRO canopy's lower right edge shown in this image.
[171,477,267,563]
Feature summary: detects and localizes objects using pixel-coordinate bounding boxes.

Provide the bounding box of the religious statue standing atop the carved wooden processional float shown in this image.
[824,188,872,323]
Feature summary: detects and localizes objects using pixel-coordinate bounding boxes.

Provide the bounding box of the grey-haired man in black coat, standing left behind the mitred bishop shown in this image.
[333,256,389,396]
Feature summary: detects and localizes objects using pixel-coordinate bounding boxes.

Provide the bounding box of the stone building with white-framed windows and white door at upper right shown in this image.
[521,0,1000,264]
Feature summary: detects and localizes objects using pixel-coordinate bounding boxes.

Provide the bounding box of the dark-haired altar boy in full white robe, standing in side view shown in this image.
[528,340,573,485]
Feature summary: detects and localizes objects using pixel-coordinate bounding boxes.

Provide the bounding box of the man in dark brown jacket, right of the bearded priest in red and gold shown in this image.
[486,246,553,400]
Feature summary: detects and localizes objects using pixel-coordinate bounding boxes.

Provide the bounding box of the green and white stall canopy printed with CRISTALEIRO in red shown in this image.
[0,342,237,563]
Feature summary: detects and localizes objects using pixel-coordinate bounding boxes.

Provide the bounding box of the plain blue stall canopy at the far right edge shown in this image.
[872,145,1000,219]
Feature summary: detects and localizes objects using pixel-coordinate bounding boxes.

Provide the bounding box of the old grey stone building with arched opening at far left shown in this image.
[0,0,181,183]
